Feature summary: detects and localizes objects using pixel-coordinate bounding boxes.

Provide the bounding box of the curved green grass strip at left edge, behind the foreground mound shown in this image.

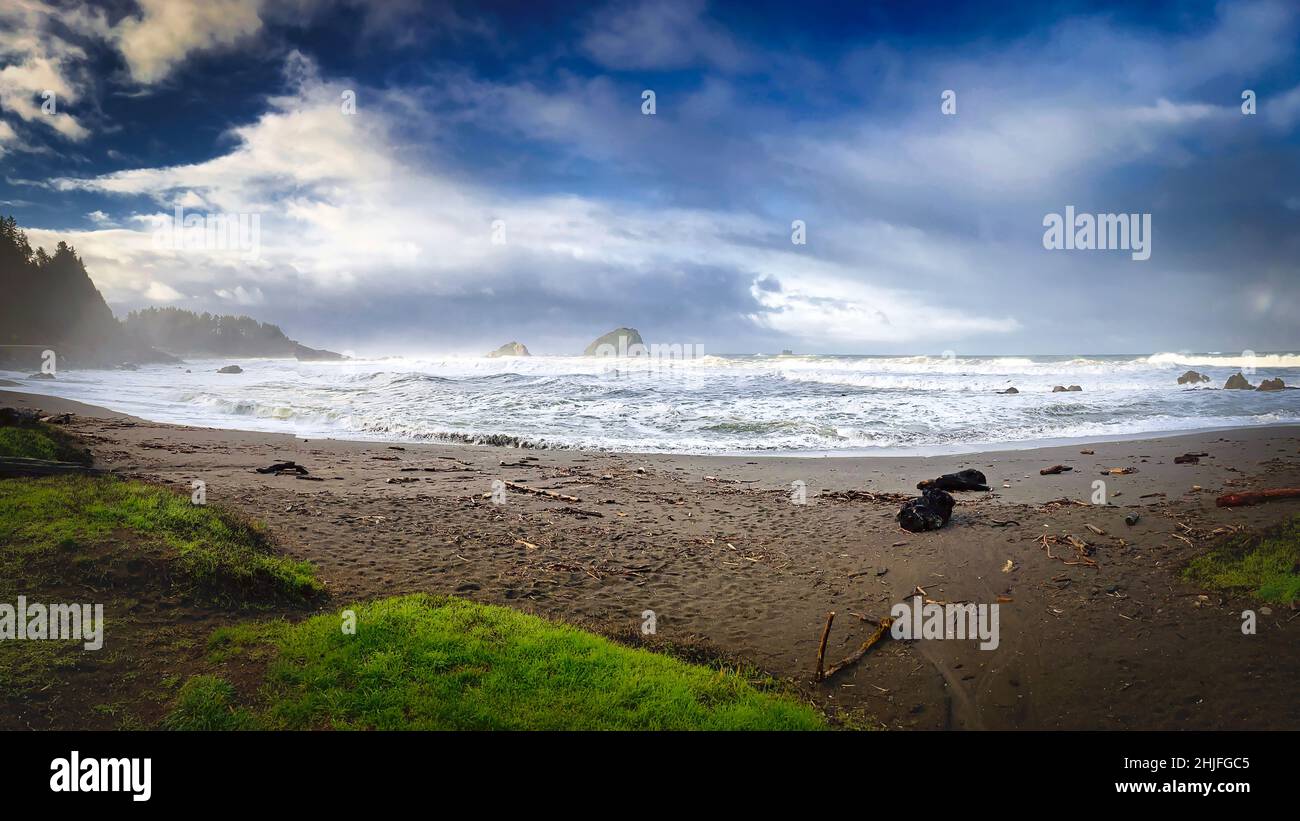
[0,475,322,600]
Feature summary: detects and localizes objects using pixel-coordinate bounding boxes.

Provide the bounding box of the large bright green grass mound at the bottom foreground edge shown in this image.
[169,594,826,730]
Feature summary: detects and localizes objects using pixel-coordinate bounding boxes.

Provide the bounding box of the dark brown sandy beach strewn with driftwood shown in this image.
[0,391,1300,729]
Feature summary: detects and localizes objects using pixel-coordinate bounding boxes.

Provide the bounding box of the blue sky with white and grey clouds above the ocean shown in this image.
[0,0,1300,356]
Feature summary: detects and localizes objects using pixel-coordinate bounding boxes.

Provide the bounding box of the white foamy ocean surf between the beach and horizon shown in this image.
[3,353,1300,456]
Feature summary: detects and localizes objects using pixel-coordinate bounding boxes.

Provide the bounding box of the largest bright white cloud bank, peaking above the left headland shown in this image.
[45,57,1013,340]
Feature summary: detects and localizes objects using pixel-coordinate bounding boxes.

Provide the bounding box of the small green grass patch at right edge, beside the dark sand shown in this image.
[1186,516,1300,604]
